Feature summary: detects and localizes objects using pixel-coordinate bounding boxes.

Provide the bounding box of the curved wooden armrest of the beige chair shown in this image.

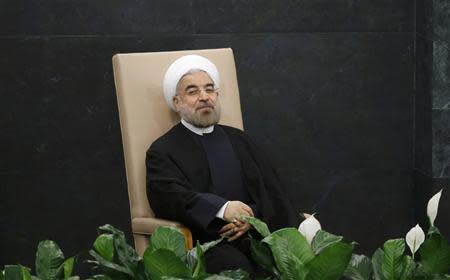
[131,218,193,250]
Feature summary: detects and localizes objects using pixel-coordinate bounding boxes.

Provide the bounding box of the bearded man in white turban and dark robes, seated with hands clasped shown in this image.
[146,55,295,273]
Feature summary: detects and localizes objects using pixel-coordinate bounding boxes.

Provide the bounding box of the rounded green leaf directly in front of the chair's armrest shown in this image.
[150,226,186,261]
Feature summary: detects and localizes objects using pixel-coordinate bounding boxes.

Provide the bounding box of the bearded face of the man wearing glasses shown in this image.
[173,71,220,127]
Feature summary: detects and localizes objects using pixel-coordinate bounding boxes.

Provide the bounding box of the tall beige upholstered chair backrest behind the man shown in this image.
[113,48,243,219]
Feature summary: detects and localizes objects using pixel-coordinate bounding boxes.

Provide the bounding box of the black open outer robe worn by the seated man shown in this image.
[146,123,296,242]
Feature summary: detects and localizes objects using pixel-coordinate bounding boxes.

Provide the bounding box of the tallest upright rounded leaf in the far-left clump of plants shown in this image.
[36,240,64,280]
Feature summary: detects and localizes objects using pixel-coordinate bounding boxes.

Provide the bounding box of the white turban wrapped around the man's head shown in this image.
[163,54,220,110]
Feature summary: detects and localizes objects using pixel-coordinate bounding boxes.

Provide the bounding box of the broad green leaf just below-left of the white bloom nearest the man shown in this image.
[262,228,314,272]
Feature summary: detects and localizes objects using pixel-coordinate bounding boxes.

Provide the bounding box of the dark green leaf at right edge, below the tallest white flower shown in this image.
[419,234,450,273]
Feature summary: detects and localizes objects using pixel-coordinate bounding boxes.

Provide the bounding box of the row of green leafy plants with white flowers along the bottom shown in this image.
[0,191,450,280]
